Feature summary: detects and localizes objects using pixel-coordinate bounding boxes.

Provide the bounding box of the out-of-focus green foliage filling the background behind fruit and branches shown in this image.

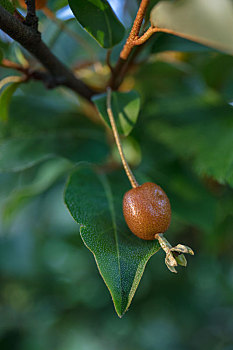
[0,1,233,350]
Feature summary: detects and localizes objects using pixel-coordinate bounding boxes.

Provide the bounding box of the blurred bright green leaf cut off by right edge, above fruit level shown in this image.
[147,104,233,186]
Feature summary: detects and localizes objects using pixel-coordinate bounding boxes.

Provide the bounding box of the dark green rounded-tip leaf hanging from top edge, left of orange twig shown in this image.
[69,0,125,48]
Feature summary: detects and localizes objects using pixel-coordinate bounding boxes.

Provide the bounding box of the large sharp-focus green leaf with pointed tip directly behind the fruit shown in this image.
[65,165,159,317]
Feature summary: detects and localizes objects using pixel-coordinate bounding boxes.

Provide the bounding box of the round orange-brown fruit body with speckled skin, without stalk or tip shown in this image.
[123,182,171,240]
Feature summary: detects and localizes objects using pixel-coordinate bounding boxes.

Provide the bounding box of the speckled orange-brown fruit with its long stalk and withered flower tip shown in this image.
[107,87,194,273]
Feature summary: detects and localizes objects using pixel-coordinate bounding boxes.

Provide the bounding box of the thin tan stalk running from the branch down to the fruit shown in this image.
[107,87,139,188]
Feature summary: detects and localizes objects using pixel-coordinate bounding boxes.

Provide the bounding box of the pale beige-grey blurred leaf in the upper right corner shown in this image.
[151,0,233,55]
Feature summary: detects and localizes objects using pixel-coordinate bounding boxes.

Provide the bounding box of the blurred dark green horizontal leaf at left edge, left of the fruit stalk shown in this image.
[0,129,107,171]
